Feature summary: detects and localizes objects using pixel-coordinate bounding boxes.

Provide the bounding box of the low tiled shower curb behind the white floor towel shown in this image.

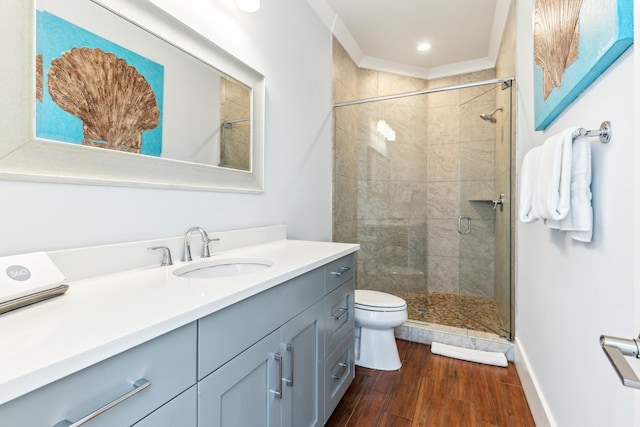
[395,320,515,362]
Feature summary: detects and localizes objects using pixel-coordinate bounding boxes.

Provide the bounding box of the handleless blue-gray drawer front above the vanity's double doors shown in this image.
[198,268,324,380]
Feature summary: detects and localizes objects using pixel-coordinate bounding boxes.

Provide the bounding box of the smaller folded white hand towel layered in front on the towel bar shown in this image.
[532,128,576,221]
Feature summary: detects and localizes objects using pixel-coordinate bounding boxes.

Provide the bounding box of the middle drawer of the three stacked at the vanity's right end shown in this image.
[324,279,355,354]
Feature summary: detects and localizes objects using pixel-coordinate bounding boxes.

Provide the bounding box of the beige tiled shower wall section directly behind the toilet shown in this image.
[358,69,428,295]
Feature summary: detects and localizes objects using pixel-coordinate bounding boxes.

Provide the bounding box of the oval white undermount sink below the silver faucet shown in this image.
[173,258,273,279]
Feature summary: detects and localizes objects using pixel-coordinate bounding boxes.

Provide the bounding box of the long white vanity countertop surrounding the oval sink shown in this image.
[0,240,359,404]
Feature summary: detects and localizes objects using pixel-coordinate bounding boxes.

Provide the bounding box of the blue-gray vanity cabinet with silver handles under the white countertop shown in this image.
[0,255,354,427]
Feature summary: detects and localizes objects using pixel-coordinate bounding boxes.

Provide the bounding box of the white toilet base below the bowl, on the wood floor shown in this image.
[355,327,402,371]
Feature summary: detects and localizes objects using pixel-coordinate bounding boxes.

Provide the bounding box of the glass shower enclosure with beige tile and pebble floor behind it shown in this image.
[334,79,513,339]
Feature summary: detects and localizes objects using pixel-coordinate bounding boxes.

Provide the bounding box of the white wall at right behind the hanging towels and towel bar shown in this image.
[516,1,638,427]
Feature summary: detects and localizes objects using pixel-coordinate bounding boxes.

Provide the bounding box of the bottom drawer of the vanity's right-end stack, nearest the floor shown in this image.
[324,330,355,423]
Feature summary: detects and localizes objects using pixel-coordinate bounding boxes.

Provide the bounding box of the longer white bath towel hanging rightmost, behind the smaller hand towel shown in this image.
[545,137,593,242]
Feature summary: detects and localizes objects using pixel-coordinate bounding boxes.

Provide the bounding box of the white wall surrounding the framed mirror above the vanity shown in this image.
[0,0,332,256]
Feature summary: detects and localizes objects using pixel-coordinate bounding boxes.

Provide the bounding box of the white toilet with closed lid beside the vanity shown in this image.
[354,289,407,371]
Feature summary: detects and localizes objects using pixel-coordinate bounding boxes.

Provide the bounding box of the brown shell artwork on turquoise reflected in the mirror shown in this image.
[36,11,164,156]
